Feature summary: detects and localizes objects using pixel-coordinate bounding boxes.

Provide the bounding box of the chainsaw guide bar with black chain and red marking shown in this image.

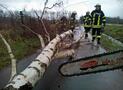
[58,50,123,77]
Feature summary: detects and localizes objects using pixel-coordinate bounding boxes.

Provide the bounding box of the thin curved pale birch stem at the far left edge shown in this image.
[0,33,17,80]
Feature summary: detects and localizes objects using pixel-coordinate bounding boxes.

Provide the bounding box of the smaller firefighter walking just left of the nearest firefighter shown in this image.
[83,11,92,39]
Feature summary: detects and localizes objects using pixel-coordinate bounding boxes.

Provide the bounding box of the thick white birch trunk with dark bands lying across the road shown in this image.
[5,30,72,90]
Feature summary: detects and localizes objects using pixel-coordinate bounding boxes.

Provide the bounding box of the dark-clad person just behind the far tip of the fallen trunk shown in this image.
[69,11,77,31]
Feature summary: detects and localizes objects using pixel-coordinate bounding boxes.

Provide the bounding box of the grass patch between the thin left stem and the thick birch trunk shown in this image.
[10,38,40,59]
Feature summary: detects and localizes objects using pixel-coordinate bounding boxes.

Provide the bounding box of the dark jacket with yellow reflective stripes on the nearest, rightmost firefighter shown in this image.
[91,10,106,28]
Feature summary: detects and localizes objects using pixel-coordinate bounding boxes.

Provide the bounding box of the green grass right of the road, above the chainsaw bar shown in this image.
[102,25,123,51]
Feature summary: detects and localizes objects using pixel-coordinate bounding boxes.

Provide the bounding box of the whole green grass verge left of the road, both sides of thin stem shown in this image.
[0,35,40,69]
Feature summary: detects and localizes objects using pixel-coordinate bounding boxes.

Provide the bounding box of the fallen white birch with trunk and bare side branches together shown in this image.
[0,0,78,90]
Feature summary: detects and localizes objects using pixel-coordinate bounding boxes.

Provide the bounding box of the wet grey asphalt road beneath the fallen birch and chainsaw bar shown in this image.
[0,27,123,90]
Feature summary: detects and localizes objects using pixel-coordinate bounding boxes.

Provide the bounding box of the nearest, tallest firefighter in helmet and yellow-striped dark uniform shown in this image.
[91,4,106,45]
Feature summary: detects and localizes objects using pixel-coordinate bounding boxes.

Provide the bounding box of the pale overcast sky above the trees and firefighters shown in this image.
[0,0,123,18]
